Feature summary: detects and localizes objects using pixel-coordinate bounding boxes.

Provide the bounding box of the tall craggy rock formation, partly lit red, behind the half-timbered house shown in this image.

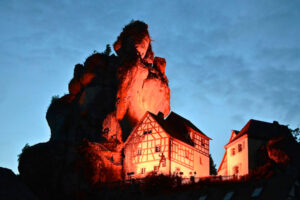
[19,21,170,199]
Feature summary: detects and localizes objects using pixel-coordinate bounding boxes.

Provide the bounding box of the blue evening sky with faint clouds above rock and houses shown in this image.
[0,0,300,172]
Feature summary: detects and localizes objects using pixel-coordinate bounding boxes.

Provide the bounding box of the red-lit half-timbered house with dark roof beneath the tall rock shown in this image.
[123,112,210,178]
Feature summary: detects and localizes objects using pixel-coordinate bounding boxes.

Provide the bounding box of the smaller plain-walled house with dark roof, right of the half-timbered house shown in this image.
[218,119,290,176]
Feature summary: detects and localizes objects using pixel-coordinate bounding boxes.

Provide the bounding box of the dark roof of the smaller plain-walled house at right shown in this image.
[228,119,291,144]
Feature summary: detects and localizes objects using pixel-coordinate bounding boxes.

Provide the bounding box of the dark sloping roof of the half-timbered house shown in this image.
[149,112,210,146]
